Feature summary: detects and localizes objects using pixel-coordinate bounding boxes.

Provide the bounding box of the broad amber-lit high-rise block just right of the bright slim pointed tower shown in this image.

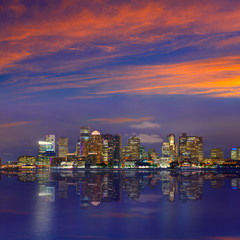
[179,133,203,162]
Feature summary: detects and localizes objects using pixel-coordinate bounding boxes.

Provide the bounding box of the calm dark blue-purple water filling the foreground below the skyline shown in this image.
[0,171,240,240]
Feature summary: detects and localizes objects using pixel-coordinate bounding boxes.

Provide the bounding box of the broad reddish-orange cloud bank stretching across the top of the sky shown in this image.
[0,0,240,73]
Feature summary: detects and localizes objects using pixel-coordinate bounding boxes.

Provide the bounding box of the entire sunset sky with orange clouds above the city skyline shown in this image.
[0,0,240,161]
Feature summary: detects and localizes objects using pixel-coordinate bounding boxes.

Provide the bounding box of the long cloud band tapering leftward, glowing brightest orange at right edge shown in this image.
[4,56,240,99]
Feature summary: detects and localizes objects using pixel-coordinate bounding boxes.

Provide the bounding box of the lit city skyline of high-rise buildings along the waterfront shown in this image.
[0,126,240,165]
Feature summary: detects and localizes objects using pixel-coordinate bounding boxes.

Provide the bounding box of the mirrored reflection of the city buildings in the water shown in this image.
[2,170,240,208]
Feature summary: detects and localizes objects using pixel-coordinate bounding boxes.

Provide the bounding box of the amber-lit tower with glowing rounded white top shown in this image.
[89,131,102,165]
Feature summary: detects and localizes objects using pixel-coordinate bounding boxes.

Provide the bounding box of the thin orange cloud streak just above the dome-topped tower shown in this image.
[90,117,154,124]
